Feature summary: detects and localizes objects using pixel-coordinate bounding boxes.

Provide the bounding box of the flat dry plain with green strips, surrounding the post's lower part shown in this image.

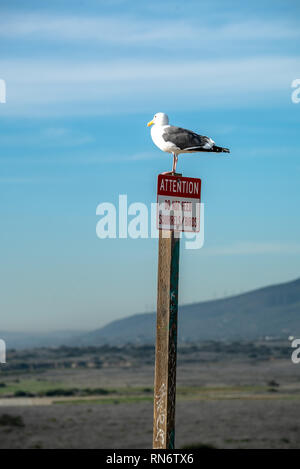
[0,346,300,449]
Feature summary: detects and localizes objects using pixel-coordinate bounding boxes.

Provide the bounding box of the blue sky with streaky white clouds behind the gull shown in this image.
[0,0,300,332]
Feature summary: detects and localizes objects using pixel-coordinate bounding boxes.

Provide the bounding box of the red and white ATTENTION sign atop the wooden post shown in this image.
[157,174,201,232]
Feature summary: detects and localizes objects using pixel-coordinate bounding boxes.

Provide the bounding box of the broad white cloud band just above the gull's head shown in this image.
[0,57,299,115]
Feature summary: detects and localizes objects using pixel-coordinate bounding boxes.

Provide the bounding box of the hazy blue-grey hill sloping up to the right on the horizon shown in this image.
[73,279,300,345]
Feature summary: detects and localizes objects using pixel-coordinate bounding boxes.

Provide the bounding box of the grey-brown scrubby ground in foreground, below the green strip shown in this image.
[0,400,300,449]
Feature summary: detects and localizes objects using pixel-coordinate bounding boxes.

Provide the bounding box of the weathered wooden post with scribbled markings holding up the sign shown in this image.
[153,230,180,449]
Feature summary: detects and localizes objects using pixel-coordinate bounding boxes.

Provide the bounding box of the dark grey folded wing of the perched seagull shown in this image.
[162,126,211,151]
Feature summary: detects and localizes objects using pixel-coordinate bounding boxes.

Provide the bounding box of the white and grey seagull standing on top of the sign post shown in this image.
[147,112,230,173]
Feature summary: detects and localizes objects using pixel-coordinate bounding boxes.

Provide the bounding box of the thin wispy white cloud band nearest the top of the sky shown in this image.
[0,13,300,44]
